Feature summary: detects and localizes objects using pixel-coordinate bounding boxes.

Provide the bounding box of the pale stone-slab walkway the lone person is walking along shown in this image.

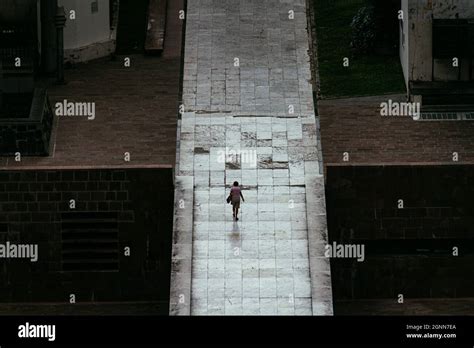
[170,0,332,315]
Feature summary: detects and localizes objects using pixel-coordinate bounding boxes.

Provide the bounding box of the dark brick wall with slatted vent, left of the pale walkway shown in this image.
[0,169,173,313]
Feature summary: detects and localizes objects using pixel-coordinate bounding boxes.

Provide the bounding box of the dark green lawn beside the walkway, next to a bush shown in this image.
[311,0,406,98]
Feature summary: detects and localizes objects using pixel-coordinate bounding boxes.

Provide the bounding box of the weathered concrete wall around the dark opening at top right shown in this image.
[402,0,474,81]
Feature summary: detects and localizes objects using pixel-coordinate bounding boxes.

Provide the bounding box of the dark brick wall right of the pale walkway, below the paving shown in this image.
[326,166,474,300]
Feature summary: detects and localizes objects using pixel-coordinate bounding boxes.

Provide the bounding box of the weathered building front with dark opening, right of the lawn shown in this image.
[399,0,474,106]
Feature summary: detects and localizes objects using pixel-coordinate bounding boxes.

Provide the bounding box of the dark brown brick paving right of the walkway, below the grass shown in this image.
[318,96,474,166]
